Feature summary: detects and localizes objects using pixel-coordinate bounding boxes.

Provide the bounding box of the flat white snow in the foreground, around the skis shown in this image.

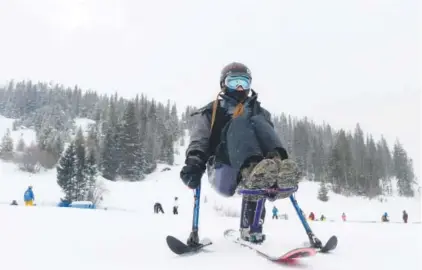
[0,205,421,270]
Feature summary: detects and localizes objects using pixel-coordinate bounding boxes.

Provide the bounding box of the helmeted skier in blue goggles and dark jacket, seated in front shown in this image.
[180,62,301,244]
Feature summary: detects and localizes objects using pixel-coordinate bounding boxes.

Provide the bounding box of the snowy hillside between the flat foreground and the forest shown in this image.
[0,117,421,222]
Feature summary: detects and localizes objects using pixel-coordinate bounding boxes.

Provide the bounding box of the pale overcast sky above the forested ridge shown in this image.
[0,0,422,181]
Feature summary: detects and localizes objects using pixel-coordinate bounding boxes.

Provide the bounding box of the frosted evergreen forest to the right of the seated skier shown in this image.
[182,107,417,201]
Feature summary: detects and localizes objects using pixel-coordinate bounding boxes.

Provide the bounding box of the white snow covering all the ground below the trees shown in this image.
[0,120,422,270]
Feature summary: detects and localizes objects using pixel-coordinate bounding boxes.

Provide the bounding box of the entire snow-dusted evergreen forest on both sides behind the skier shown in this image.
[0,81,415,199]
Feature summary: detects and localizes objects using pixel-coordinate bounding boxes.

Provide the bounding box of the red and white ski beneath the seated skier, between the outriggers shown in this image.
[224,229,317,264]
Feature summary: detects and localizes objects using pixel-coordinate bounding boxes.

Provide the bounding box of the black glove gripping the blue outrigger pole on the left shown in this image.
[180,156,205,189]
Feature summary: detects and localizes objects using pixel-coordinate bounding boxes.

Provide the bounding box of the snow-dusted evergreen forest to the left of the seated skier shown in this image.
[0,81,181,200]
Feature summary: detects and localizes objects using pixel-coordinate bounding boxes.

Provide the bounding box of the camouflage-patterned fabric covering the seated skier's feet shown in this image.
[239,157,301,201]
